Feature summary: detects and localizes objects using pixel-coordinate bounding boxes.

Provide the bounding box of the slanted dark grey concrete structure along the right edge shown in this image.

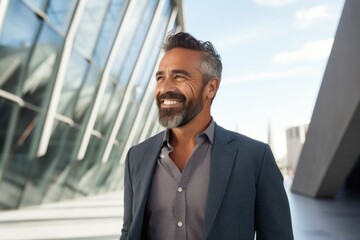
[291,0,360,198]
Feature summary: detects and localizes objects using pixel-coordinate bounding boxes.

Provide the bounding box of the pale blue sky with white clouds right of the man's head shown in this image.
[183,0,344,157]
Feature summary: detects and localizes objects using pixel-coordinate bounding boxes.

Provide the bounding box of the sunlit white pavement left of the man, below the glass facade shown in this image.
[0,192,123,240]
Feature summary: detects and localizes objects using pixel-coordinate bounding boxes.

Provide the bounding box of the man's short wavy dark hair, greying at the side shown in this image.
[162,32,222,84]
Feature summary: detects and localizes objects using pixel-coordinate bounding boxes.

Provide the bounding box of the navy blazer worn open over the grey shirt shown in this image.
[120,125,293,240]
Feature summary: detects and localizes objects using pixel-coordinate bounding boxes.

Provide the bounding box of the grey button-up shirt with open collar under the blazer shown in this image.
[144,120,215,240]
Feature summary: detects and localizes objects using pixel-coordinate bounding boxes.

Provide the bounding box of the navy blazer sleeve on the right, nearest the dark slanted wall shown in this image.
[255,145,294,240]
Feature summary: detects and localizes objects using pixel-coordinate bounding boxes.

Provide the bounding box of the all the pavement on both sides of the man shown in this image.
[0,180,360,240]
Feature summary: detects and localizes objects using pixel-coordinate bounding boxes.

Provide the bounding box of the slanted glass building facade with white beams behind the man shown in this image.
[0,0,183,210]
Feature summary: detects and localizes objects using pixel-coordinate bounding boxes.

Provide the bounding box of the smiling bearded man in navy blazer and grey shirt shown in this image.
[120,32,293,240]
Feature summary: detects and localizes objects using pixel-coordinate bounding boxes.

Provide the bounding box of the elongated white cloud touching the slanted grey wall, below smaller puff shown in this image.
[274,38,334,64]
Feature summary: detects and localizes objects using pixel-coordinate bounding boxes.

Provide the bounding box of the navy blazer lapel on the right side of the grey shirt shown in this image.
[204,125,237,239]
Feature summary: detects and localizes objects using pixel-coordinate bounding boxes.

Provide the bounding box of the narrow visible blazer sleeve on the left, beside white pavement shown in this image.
[120,149,133,240]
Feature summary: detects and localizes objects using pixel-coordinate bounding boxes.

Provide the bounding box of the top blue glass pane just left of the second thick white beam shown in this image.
[94,0,129,67]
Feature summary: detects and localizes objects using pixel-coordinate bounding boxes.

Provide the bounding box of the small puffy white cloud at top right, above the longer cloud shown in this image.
[295,5,331,29]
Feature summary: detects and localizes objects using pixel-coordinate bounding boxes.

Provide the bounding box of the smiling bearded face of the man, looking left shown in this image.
[155,48,204,128]
